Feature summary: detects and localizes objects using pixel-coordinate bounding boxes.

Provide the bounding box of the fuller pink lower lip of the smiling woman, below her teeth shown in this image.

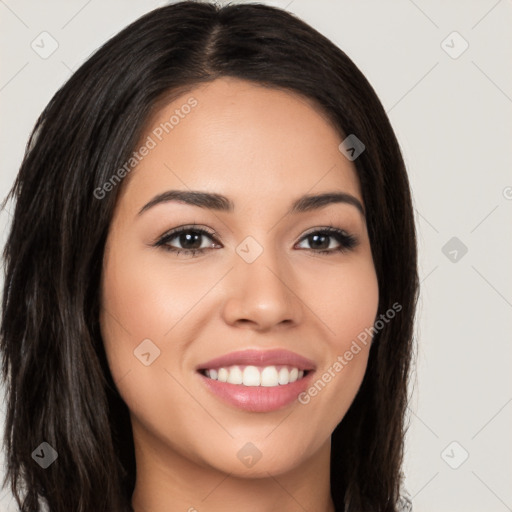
[199,371,314,412]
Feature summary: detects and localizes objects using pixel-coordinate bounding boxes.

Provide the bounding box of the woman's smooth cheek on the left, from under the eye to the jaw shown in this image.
[100,232,218,415]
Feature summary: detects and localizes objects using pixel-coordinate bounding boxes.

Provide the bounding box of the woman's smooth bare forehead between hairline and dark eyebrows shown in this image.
[118,78,362,216]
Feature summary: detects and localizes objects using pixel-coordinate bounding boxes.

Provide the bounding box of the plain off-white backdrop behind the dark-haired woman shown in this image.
[0,0,512,512]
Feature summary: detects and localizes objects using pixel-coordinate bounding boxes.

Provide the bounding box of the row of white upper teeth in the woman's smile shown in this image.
[205,366,304,387]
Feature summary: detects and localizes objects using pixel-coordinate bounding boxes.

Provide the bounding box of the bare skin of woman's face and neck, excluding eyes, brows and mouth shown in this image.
[100,78,378,512]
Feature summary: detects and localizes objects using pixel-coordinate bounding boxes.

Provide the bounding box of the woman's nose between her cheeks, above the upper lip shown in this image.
[223,241,303,331]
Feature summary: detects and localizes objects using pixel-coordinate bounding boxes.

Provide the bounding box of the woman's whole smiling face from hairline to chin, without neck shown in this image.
[100,78,378,476]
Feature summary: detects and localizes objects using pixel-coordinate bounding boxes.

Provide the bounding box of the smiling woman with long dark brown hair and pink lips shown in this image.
[1,2,418,512]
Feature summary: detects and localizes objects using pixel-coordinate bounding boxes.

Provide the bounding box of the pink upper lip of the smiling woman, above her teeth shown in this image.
[196,349,316,370]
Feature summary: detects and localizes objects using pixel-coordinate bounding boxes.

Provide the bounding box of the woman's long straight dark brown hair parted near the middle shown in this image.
[0,1,418,512]
